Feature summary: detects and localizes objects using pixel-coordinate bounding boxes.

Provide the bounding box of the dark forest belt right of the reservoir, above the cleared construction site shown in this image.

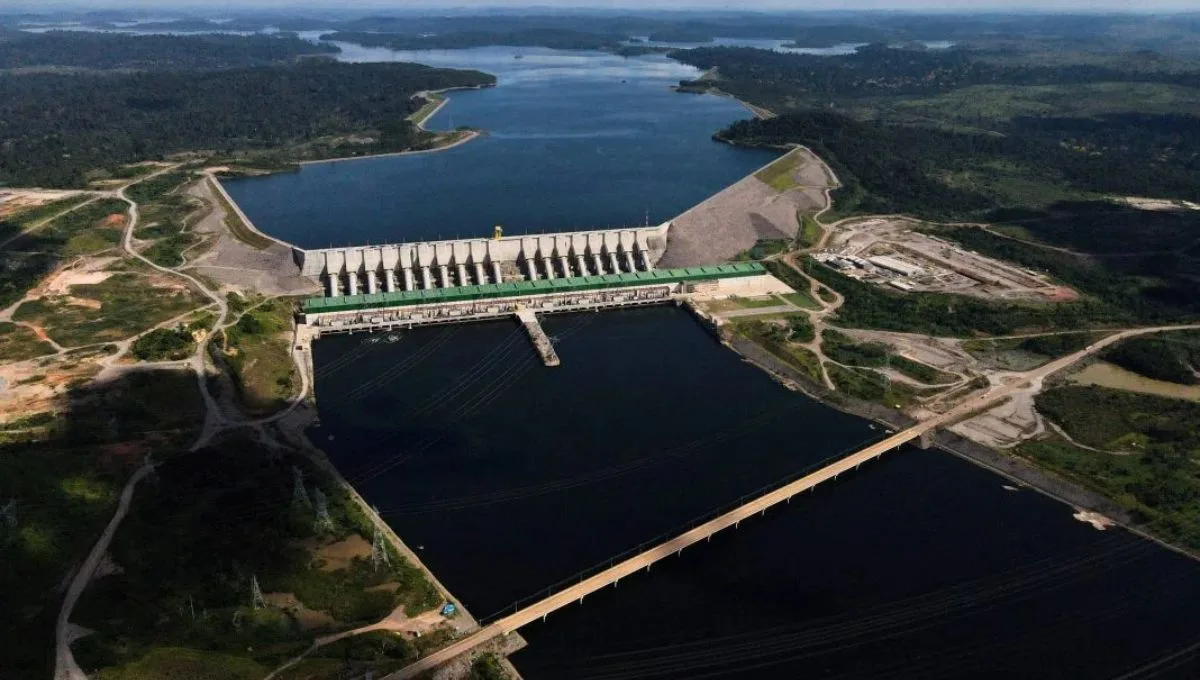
[718,112,1200,215]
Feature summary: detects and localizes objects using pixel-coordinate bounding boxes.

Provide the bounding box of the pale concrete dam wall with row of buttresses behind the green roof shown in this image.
[294,222,671,297]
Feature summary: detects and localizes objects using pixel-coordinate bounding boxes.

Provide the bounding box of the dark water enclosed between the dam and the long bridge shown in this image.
[314,308,881,616]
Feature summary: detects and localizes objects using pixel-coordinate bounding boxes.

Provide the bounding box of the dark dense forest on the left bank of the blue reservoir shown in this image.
[0,60,494,187]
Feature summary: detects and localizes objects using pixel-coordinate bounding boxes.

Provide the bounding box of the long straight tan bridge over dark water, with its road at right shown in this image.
[384,314,1180,680]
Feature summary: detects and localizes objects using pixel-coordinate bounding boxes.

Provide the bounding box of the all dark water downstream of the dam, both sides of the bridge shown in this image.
[313,308,1200,680]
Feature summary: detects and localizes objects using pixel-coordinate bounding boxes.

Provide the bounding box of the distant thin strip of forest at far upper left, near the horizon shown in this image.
[0,31,340,71]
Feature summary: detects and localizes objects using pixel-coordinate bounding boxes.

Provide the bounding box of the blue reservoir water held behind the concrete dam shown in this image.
[226,46,773,248]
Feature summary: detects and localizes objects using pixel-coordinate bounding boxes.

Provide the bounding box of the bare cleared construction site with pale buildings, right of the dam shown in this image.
[814,217,1076,301]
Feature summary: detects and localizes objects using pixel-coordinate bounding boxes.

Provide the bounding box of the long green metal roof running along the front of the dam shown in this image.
[304,263,767,313]
